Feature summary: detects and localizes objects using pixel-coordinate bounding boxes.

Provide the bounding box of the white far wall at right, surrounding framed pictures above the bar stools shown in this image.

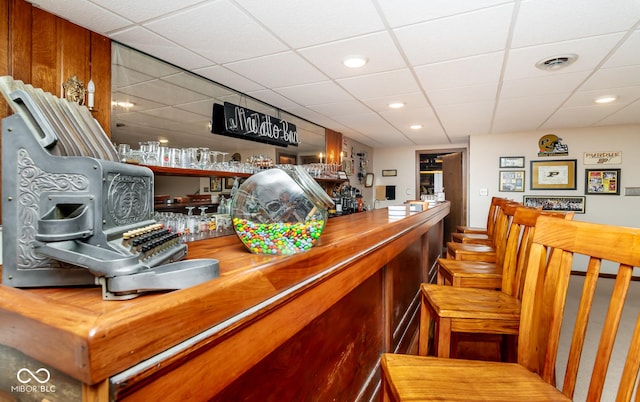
[469,125,640,228]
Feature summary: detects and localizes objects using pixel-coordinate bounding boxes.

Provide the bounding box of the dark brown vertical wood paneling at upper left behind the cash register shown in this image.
[0,0,111,223]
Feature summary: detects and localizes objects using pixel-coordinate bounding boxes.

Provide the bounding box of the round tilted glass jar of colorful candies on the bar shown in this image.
[231,166,333,255]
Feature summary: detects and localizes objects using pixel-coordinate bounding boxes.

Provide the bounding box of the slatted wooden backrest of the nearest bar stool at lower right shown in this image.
[518,216,640,401]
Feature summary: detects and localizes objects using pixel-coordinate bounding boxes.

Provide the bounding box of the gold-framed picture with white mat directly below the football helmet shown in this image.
[531,159,577,190]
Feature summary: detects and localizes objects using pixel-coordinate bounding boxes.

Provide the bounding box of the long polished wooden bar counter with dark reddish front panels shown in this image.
[0,202,449,401]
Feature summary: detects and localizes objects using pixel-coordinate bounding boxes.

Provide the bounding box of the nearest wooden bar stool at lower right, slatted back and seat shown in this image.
[381,216,640,402]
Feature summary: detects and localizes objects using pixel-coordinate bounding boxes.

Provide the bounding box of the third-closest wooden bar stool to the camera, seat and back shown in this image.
[436,209,575,289]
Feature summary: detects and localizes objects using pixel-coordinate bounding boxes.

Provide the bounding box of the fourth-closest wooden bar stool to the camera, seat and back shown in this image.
[447,202,522,262]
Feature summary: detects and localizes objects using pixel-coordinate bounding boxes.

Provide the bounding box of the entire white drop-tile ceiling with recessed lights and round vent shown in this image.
[27,0,640,148]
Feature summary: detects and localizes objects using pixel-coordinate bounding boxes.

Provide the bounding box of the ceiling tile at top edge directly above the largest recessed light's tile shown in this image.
[236,0,384,48]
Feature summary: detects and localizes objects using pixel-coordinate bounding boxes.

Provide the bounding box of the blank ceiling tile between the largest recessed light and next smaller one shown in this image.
[336,69,416,99]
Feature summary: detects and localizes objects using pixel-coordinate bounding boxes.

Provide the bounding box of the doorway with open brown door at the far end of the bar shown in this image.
[416,148,467,243]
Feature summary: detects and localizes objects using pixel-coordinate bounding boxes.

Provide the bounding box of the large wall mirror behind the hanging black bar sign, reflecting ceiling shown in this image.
[111,42,326,163]
